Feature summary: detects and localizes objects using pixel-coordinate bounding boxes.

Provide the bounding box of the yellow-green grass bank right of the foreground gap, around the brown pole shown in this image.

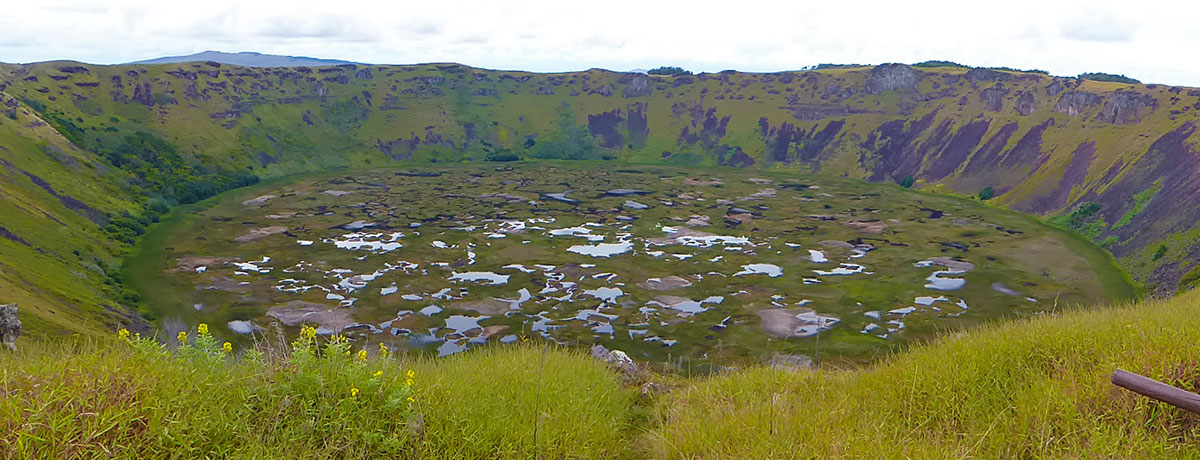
[648,292,1200,459]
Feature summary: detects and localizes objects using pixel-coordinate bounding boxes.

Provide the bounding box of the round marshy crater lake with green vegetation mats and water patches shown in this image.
[125,162,1134,372]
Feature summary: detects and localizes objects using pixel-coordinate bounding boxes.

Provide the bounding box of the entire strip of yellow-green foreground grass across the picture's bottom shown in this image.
[0,293,1200,459]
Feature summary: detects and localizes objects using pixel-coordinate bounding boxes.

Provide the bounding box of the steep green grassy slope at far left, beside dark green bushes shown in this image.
[0,92,139,335]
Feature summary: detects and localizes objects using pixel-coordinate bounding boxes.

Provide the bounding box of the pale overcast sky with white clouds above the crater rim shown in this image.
[0,0,1200,86]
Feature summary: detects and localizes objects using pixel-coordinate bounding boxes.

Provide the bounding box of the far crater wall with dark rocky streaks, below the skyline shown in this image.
[7,62,1200,297]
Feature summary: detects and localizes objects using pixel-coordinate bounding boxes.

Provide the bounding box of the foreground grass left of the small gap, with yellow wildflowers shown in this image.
[0,331,630,459]
